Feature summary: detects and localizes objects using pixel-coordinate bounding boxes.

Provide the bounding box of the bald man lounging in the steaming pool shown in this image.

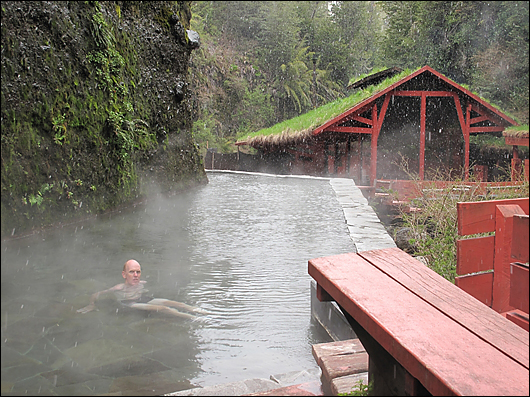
[77,259,204,319]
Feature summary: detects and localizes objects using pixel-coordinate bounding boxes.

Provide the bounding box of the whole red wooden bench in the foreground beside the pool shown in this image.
[309,248,529,395]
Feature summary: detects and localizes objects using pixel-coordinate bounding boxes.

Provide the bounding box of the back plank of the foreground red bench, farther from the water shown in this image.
[359,248,530,369]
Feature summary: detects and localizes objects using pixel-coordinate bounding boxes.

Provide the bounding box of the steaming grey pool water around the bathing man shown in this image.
[1,173,354,394]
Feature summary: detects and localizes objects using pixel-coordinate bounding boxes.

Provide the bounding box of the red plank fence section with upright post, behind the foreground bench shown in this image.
[455,198,529,331]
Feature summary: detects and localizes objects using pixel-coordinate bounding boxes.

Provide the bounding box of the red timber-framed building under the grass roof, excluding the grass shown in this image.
[236,66,517,186]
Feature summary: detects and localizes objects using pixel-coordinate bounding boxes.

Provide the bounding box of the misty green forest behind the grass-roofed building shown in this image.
[189,1,529,154]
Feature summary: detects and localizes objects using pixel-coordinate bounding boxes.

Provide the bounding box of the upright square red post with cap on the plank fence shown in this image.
[491,204,524,313]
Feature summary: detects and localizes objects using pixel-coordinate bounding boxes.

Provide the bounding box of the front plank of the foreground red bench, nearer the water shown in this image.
[309,254,529,395]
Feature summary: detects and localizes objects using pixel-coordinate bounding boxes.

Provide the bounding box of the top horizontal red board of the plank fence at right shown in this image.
[456,197,529,236]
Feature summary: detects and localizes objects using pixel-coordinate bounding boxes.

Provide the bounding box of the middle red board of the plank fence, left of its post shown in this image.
[456,236,495,274]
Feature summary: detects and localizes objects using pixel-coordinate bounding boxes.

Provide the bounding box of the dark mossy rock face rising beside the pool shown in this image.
[1,1,207,237]
